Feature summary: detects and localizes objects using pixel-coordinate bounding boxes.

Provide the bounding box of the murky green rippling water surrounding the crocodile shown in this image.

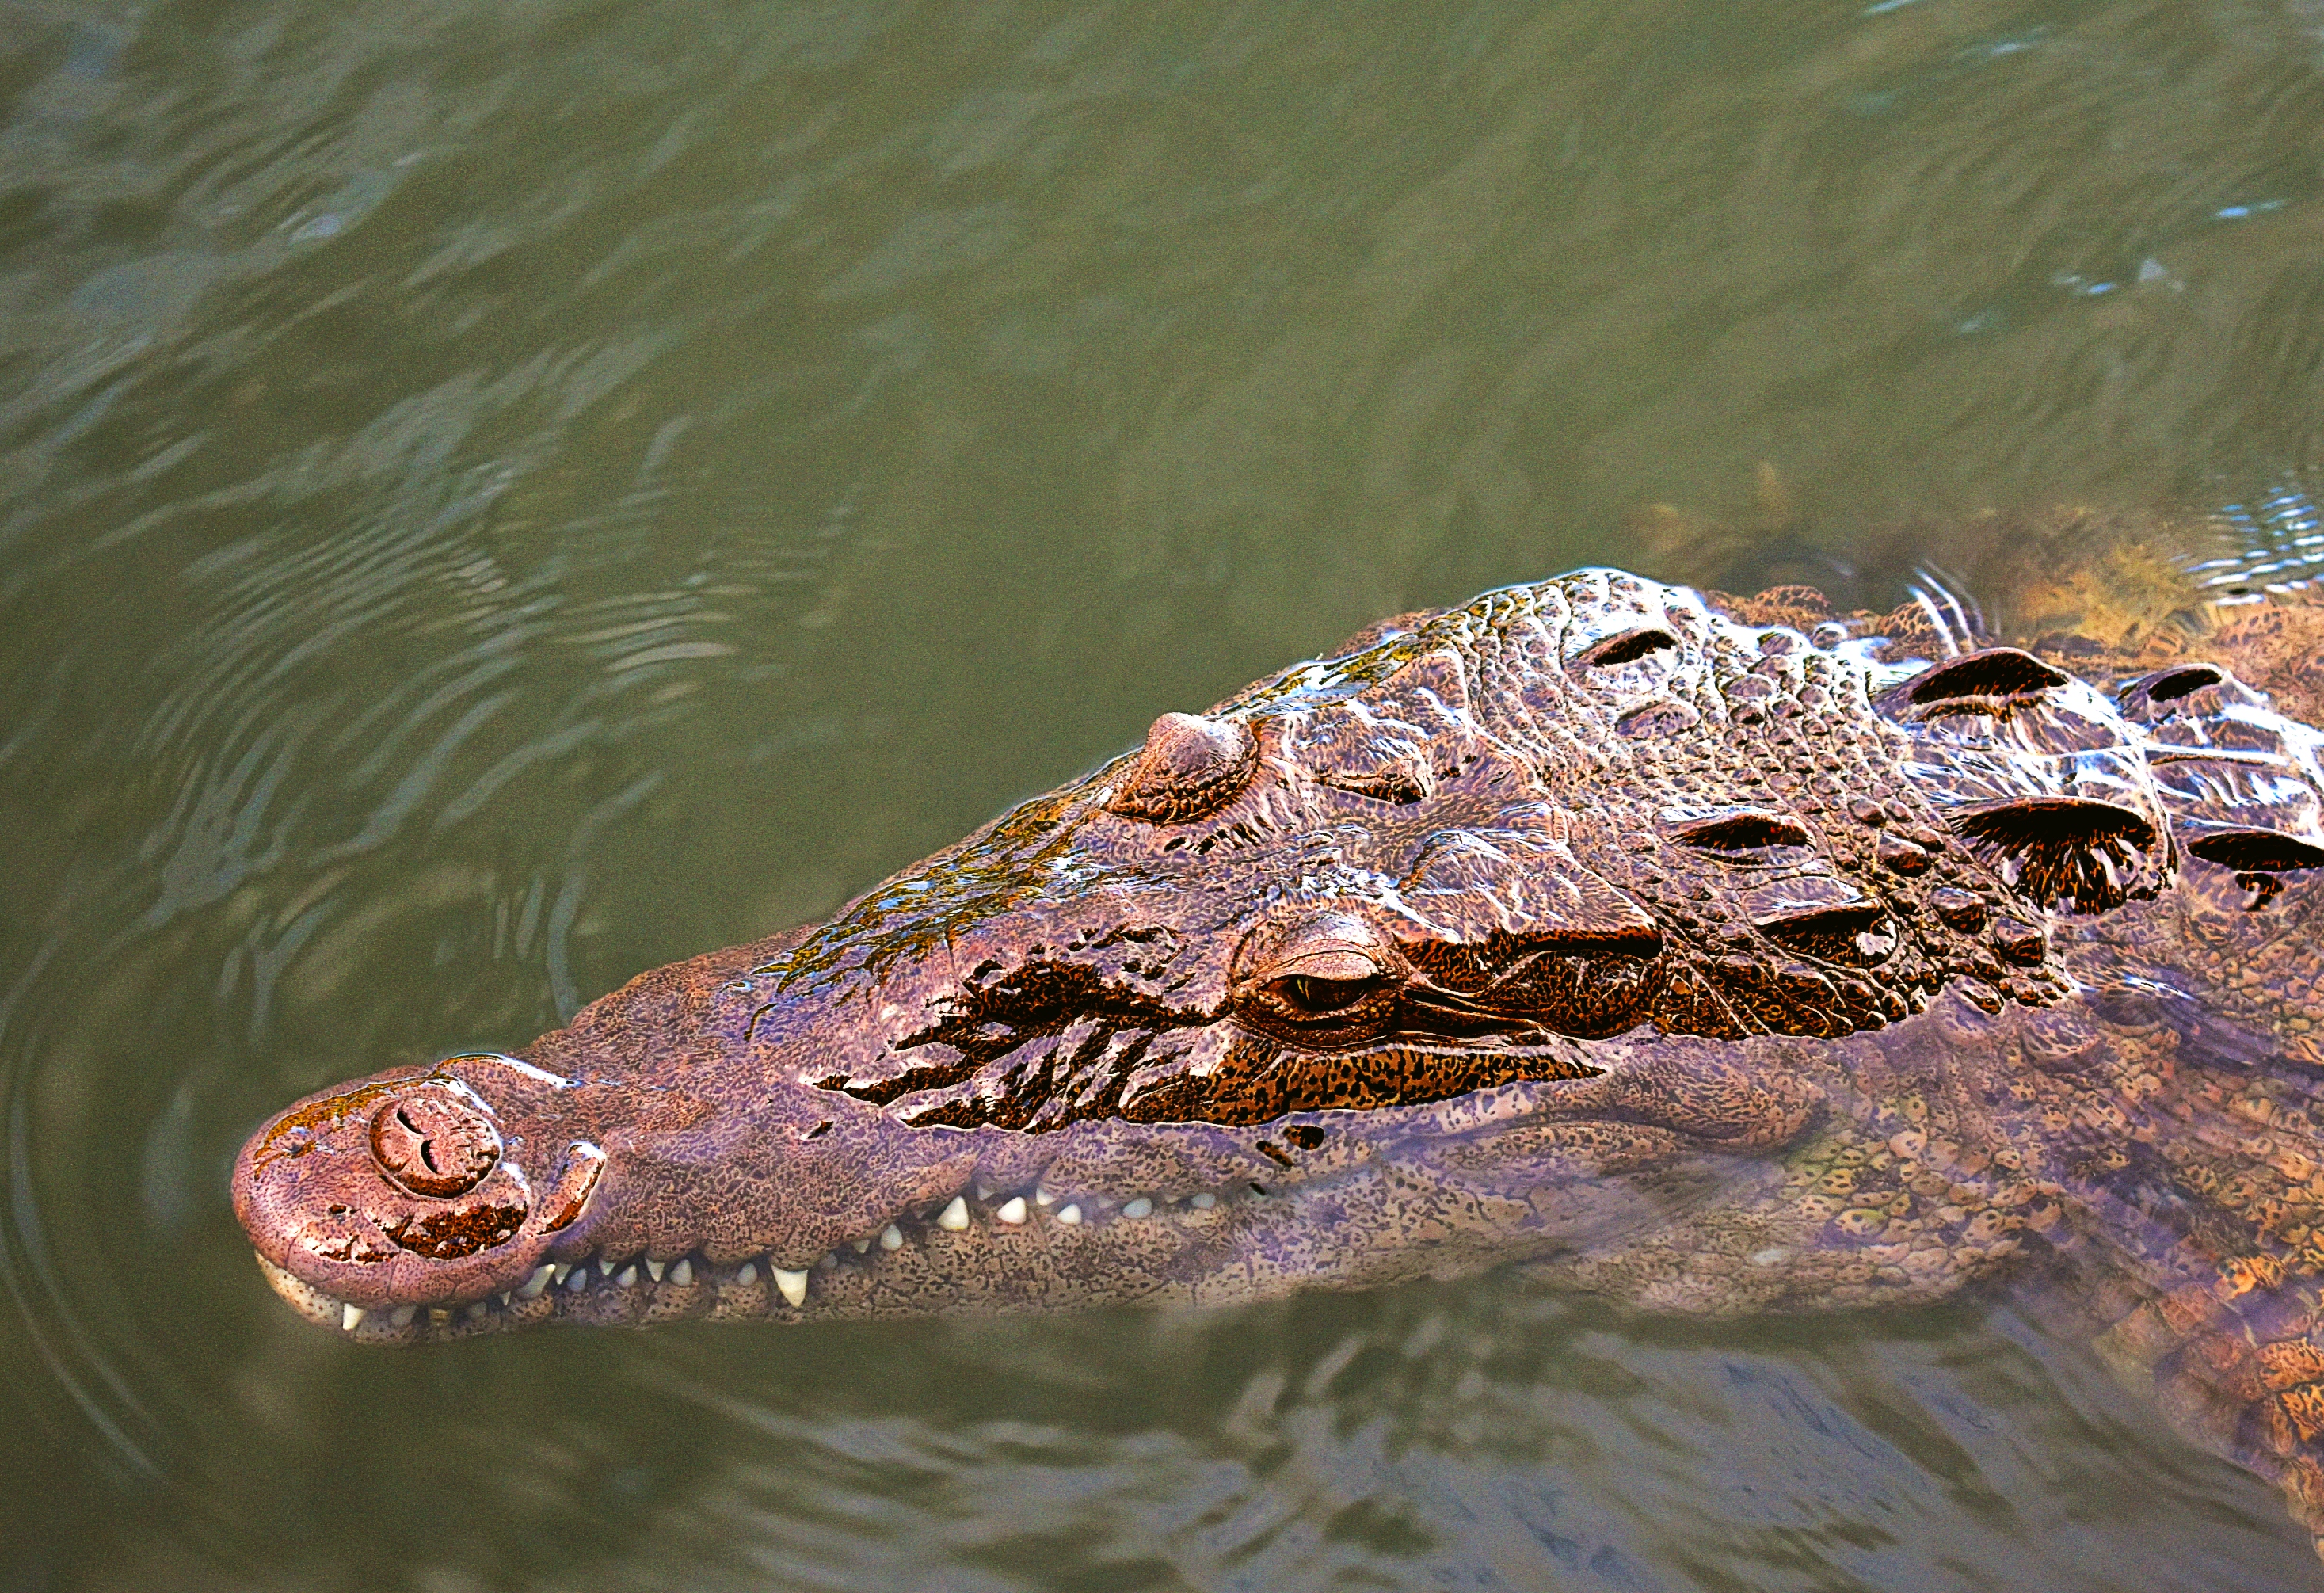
[13,0,2324,1593]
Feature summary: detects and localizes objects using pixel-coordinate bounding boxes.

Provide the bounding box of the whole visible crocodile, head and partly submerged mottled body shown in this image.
[234,570,2324,1553]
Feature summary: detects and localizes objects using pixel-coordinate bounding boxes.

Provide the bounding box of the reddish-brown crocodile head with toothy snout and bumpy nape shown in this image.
[232,570,2287,1340]
